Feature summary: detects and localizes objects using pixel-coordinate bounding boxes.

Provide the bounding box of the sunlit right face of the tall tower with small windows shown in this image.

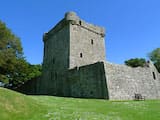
[70,13,105,68]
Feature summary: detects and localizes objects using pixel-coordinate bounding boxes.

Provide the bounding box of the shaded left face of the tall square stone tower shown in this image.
[37,21,69,95]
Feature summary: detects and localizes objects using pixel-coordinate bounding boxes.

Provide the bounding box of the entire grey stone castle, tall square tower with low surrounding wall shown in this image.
[36,12,160,100]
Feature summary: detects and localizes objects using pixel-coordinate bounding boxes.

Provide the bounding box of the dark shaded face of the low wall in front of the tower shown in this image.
[62,62,108,99]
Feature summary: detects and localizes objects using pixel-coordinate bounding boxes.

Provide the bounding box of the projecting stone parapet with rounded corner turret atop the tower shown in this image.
[43,12,105,42]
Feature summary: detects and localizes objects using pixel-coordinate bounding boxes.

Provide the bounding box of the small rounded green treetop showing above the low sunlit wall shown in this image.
[125,58,146,67]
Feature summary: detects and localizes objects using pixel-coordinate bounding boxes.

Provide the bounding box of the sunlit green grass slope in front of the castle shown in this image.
[0,88,160,120]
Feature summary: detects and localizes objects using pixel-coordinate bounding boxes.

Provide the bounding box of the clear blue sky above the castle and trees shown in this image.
[0,0,160,64]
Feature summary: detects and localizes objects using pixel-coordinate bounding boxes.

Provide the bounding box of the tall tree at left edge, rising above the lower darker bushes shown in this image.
[0,21,24,86]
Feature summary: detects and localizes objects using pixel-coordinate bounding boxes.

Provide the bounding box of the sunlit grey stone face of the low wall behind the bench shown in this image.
[105,62,160,100]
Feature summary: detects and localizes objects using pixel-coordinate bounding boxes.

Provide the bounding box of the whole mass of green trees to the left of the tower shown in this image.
[0,21,41,87]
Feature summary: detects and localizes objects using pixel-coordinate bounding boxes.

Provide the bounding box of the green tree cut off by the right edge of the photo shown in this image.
[148,48,160,72]
